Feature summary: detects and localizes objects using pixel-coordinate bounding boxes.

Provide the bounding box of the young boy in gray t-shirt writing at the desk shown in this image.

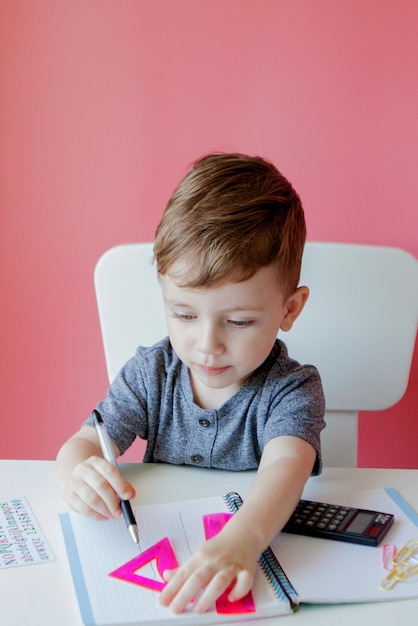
[57,154,325,613]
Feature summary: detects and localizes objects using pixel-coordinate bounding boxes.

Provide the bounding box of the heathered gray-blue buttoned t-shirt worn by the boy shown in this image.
[85,338,325,474]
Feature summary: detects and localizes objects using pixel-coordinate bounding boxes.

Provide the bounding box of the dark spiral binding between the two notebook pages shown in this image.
[225,491,299,609]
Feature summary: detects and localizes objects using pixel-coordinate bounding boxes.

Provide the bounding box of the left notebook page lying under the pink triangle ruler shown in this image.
[60,497,289,626]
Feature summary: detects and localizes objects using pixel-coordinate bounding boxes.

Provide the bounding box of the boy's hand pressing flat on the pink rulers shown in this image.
[160,532,258,613]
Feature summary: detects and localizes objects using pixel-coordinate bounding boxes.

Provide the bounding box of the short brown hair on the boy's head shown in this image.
[154,154,306,297]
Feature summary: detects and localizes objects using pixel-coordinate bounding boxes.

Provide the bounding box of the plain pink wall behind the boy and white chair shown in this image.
[0,0,418,467]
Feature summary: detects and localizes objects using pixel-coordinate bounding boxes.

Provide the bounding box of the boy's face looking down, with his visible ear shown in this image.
[160,261,307,408]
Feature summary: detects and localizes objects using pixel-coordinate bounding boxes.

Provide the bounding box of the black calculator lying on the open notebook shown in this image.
[282,500,395,546]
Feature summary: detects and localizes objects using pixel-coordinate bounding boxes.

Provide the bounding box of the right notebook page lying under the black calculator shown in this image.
[272,489,418,604]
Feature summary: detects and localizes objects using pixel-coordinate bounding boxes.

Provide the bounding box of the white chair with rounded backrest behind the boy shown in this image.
[95,242,418,467]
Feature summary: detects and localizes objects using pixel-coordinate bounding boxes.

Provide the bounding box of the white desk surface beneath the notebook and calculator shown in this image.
[0,461,418,626]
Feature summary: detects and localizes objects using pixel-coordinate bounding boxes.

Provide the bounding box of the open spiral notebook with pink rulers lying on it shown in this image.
[60,489,418,626]
